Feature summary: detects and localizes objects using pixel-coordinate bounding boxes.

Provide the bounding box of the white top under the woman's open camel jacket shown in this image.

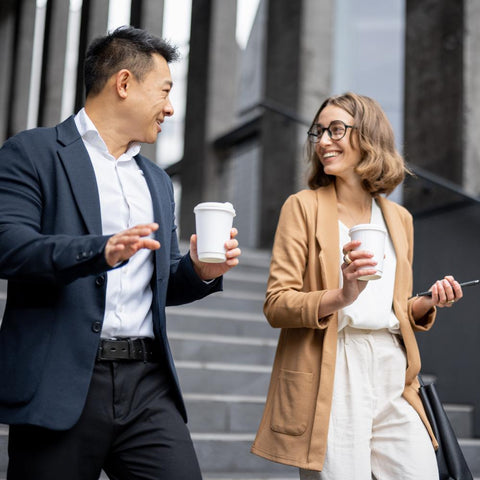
[338,199,400,332]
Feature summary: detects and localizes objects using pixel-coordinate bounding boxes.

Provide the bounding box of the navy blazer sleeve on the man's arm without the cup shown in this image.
[0,137,110,282]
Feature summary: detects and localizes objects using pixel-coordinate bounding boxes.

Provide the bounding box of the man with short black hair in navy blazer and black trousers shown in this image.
[0,27,240,480]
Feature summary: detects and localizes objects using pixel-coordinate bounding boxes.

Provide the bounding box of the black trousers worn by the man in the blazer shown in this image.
[7,361,202,480]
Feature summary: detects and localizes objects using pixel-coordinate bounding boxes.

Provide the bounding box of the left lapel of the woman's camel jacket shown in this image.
[316,183,340,288]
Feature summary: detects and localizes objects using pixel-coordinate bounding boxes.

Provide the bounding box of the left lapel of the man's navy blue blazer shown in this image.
[57,117,102,235]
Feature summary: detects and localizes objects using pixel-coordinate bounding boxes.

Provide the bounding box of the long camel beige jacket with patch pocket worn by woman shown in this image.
[251,185,437,471]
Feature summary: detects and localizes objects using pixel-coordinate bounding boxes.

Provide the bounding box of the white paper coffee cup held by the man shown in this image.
[193,202,235,263]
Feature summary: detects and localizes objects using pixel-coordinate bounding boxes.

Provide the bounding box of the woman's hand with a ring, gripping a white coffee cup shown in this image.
[341,240,377,305]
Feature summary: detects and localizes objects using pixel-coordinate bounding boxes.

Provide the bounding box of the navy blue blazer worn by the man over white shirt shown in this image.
[0,117,222,430]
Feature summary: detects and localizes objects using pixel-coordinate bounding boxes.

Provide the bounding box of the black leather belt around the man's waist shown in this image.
[97,337,160,362]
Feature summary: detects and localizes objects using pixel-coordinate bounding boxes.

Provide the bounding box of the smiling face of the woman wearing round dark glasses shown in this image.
[315,105,361,179]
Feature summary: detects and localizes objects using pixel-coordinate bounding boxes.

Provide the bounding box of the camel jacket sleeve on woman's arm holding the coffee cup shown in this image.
[264,195,330,328]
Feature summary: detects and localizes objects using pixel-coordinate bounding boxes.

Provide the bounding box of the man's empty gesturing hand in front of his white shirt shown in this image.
[105,223,160,267]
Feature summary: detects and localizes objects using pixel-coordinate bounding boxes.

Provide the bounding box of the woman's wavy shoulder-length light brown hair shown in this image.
[307,92,411,196]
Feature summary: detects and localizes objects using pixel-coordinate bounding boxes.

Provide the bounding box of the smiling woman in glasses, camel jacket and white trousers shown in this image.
[252,93,462,480]
